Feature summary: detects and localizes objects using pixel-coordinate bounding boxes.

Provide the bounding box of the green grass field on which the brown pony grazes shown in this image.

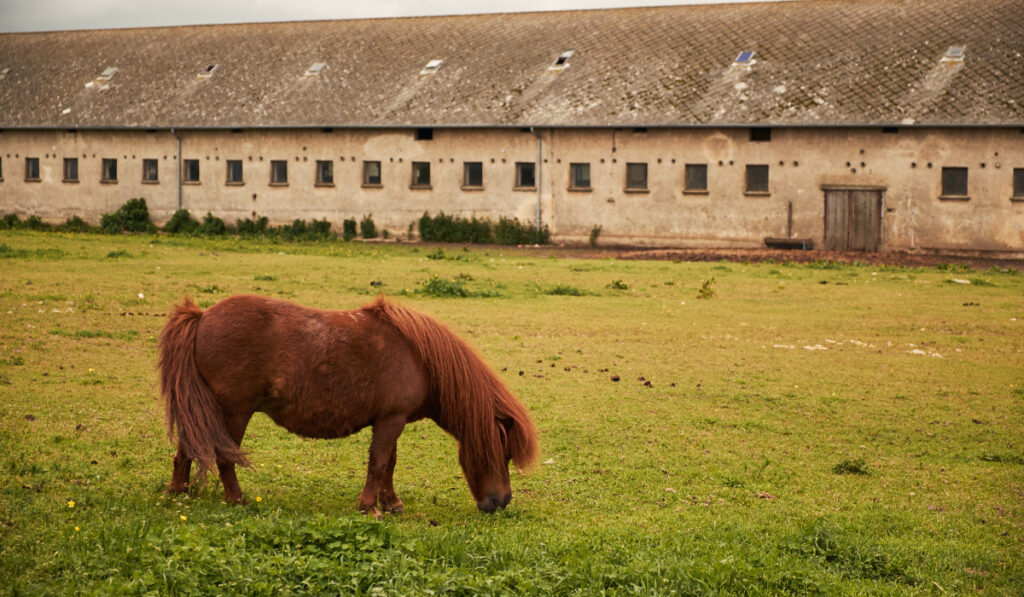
[0,231,1024,595]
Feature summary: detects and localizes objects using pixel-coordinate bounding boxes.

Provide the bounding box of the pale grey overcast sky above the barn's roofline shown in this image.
[0,0,786,33]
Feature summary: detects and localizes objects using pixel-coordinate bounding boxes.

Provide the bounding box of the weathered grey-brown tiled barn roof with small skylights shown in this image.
[0,0,1024,128]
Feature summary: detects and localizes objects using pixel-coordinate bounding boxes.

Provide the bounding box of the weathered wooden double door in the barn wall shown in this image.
[825,188,882,252]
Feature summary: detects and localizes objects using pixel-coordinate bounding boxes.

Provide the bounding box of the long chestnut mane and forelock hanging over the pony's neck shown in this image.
[362,295,538,469]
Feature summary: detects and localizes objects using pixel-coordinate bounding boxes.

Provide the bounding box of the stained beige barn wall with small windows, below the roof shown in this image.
[0,128,1024,254]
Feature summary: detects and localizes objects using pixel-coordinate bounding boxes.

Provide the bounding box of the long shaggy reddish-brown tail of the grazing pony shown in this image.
[160,298,249,478]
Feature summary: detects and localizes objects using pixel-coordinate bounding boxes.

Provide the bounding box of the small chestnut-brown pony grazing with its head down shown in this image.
[160,295,538,516]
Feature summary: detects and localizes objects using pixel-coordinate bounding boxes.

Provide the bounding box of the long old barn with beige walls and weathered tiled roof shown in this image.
[0,0,1024,256]
